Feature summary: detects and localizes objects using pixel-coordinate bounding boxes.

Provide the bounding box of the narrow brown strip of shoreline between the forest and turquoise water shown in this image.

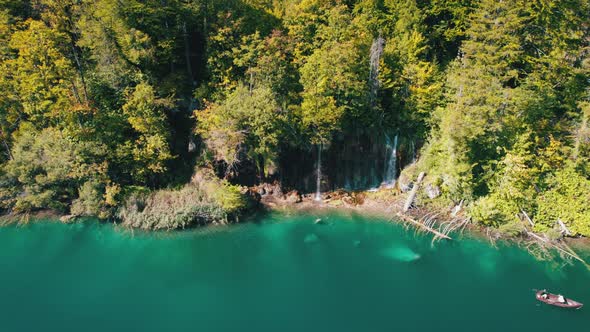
[0,189,590,262]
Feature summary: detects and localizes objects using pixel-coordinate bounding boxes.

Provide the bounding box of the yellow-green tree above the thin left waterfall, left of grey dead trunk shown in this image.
[300,5,374,144]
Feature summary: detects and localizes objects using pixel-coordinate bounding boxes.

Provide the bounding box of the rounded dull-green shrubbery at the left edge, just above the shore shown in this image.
[0,128,106,212]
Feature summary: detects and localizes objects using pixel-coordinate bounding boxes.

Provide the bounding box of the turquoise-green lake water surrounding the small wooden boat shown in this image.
[0,214,590,332]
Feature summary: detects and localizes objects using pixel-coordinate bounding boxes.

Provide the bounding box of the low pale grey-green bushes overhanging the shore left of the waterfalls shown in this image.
[3,169,259,231]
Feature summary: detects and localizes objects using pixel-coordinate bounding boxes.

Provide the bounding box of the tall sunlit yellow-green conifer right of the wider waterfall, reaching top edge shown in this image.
[426,1,525,200]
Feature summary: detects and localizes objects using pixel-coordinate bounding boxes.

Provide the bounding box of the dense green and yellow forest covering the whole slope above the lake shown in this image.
[0,0,590,235]
